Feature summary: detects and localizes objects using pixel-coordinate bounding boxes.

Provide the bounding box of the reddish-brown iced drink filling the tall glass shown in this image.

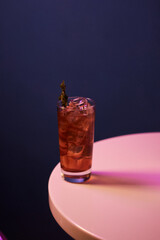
[57,98,95,172]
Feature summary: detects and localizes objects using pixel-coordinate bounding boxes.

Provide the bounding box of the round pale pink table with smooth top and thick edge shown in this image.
[48,133,160,240]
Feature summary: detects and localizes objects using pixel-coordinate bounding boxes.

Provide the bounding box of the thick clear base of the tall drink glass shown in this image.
[61,168,91,183]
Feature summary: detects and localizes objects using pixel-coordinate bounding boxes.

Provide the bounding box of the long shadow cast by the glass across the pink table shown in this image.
[85,171,160,187]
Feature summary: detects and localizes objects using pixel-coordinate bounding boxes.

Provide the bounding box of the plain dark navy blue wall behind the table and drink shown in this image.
[0,0,160,240]
